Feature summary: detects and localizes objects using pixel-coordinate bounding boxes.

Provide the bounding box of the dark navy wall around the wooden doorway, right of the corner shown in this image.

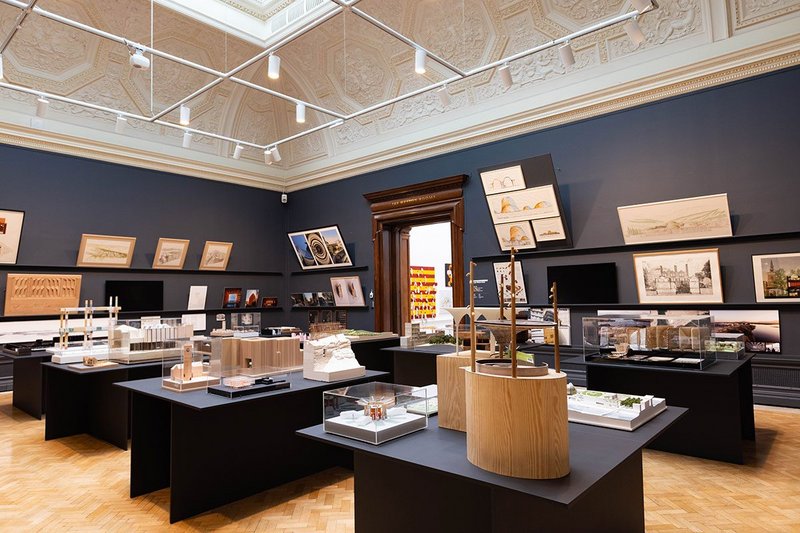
[287,68,800,355]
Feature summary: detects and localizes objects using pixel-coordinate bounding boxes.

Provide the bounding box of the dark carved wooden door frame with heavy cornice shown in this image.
[364,175,467,333]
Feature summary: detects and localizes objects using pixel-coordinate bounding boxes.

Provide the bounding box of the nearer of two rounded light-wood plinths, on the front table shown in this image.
[465,369,569,479]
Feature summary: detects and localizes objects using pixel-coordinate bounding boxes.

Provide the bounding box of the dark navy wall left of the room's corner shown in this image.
[0,145,285,318]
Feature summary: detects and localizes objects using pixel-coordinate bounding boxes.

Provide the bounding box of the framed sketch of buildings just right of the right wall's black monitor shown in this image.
[633,248,723,304]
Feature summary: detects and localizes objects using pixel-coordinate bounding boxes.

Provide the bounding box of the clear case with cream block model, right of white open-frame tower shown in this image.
[108,317,194,364]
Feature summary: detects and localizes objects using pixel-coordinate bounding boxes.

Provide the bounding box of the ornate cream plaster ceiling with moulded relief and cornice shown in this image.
[0,0,800,190]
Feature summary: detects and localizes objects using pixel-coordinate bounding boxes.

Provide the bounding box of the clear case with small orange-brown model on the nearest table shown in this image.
[322,382,428,444]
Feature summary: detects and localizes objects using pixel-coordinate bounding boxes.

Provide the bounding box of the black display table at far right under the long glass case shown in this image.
[586,355,755,464]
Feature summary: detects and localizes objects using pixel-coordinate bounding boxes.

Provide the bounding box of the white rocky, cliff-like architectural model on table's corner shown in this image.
[303,334,366,381]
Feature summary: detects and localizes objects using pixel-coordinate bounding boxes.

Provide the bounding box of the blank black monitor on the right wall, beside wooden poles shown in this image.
[547,263,619,304]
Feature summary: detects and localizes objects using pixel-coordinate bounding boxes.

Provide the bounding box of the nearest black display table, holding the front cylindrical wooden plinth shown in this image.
[298,407,686,533]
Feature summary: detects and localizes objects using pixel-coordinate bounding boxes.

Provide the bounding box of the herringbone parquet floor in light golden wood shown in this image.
[0,393,800,533]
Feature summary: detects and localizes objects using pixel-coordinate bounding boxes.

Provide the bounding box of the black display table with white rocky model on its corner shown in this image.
[117,370,387,522]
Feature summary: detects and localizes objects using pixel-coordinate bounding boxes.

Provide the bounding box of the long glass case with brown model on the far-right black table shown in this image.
[583,314,716,369]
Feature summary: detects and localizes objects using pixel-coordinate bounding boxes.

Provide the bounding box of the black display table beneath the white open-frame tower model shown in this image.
[42,361,162,450]
